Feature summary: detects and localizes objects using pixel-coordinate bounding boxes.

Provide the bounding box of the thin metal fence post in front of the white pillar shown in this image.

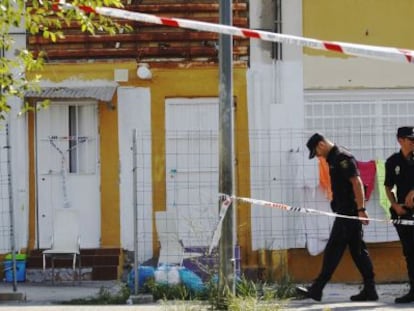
[132,129,139,295]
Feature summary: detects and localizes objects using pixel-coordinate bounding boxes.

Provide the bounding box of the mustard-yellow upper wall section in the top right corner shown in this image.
[303,0,414,57]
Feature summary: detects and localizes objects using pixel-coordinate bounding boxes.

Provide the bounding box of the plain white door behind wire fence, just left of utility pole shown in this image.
[166,98,218,246]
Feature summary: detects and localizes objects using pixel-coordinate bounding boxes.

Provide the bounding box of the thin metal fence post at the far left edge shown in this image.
[5,124,17,292]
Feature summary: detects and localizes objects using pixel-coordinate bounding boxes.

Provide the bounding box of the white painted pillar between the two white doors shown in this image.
[118,87,153,262]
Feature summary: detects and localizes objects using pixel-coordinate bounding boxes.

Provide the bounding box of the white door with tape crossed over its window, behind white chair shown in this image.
[36,102,100,248]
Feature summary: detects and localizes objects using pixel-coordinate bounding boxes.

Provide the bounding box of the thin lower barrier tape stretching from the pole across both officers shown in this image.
[225,194,414,226]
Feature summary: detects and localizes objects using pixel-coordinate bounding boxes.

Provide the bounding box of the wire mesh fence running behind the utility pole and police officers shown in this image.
[132,126,410,292]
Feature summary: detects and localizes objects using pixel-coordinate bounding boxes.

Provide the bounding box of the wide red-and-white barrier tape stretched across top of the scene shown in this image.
[56,0,414,63]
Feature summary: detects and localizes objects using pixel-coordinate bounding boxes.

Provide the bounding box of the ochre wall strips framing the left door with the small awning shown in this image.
[28,63,121,249]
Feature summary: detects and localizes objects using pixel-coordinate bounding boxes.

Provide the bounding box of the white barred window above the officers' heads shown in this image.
[305,91,414,159]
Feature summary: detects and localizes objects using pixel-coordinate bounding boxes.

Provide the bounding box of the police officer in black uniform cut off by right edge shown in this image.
[384,126,414,303]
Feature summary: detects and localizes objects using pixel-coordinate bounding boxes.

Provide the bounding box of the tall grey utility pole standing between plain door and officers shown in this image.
[218,0,235,304]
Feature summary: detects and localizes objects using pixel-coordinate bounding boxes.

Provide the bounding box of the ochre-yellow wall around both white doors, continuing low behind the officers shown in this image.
[24,62,406,282]
